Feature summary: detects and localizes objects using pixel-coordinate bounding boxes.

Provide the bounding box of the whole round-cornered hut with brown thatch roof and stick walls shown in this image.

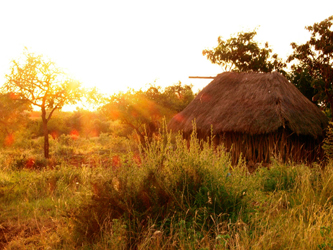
[168,72,328,164]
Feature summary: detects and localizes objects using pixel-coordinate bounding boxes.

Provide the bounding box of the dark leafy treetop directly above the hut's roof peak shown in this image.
[202,31,286,74]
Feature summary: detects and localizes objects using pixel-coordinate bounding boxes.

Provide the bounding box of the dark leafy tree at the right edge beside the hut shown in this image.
[288,16,333,120]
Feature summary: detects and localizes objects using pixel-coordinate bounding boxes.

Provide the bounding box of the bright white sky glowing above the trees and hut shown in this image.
[0,0,333,97]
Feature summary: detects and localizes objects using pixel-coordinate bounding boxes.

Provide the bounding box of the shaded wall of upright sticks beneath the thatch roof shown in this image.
[216,128,323,165]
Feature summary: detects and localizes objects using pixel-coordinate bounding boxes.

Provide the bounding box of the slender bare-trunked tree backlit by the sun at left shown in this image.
[3,49,84,158]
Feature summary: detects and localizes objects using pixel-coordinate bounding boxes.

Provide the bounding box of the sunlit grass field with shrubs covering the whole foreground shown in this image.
[0,130,333,249]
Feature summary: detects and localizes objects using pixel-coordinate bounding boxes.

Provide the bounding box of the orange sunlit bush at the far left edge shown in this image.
[0,93,30,144]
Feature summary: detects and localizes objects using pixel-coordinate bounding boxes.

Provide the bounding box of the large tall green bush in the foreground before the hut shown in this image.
[71,130,246,247]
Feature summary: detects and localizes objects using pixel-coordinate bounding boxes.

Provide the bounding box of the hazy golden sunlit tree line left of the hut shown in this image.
[0,49,194,158]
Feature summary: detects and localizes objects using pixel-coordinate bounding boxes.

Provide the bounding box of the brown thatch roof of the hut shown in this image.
[168,72,328,138]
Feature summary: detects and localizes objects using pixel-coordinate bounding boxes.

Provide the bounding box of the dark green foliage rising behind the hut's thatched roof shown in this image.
[202,21,333,118]
